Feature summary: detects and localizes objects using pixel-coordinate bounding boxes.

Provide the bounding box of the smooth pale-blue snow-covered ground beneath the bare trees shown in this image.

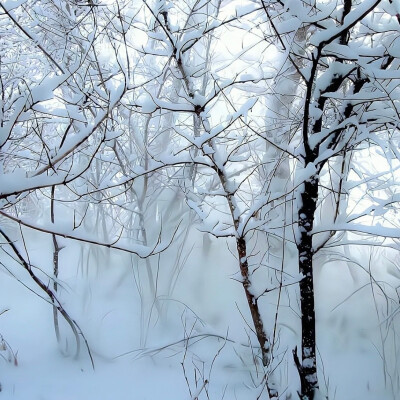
[0,227,399,400]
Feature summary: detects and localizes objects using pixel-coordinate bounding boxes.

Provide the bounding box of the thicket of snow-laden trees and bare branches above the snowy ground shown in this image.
[0,0,400,400]
